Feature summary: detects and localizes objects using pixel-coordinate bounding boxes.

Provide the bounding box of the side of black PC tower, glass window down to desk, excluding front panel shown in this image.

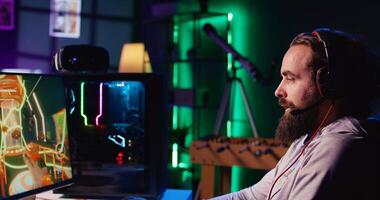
[58,77,149,196]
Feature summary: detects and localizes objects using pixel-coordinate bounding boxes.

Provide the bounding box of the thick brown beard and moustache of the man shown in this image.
[276,99,319,145]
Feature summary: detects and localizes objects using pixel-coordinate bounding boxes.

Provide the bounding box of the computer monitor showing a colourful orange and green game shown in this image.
[0,73,72,199]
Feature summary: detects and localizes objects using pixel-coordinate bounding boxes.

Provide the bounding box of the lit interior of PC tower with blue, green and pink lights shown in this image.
[69,81,145,165]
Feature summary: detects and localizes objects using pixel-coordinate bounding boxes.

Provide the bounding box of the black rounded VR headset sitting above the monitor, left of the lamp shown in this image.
[53,45,109,72]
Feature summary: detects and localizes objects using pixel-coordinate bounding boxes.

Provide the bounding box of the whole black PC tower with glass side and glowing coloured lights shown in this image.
[56,74,167,199]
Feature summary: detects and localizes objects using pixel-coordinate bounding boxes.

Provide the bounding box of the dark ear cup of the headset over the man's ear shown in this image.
[316,67,333,98]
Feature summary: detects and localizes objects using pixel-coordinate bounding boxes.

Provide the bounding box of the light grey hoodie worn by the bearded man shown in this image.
[213,117,380,200]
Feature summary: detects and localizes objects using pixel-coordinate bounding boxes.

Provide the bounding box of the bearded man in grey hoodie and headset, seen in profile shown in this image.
[211,28,380,200]
